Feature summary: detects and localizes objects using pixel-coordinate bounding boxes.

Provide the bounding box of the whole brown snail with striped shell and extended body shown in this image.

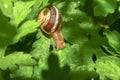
[38,6,65,50]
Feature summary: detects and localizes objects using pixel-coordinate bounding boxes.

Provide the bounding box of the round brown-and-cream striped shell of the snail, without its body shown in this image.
[38,6,62,34]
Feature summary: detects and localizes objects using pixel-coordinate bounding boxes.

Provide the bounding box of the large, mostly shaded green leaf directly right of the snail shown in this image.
[60,2,107,70]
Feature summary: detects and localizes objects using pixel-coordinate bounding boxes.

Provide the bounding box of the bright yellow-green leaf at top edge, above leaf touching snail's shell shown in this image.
[11,1,34,27]
